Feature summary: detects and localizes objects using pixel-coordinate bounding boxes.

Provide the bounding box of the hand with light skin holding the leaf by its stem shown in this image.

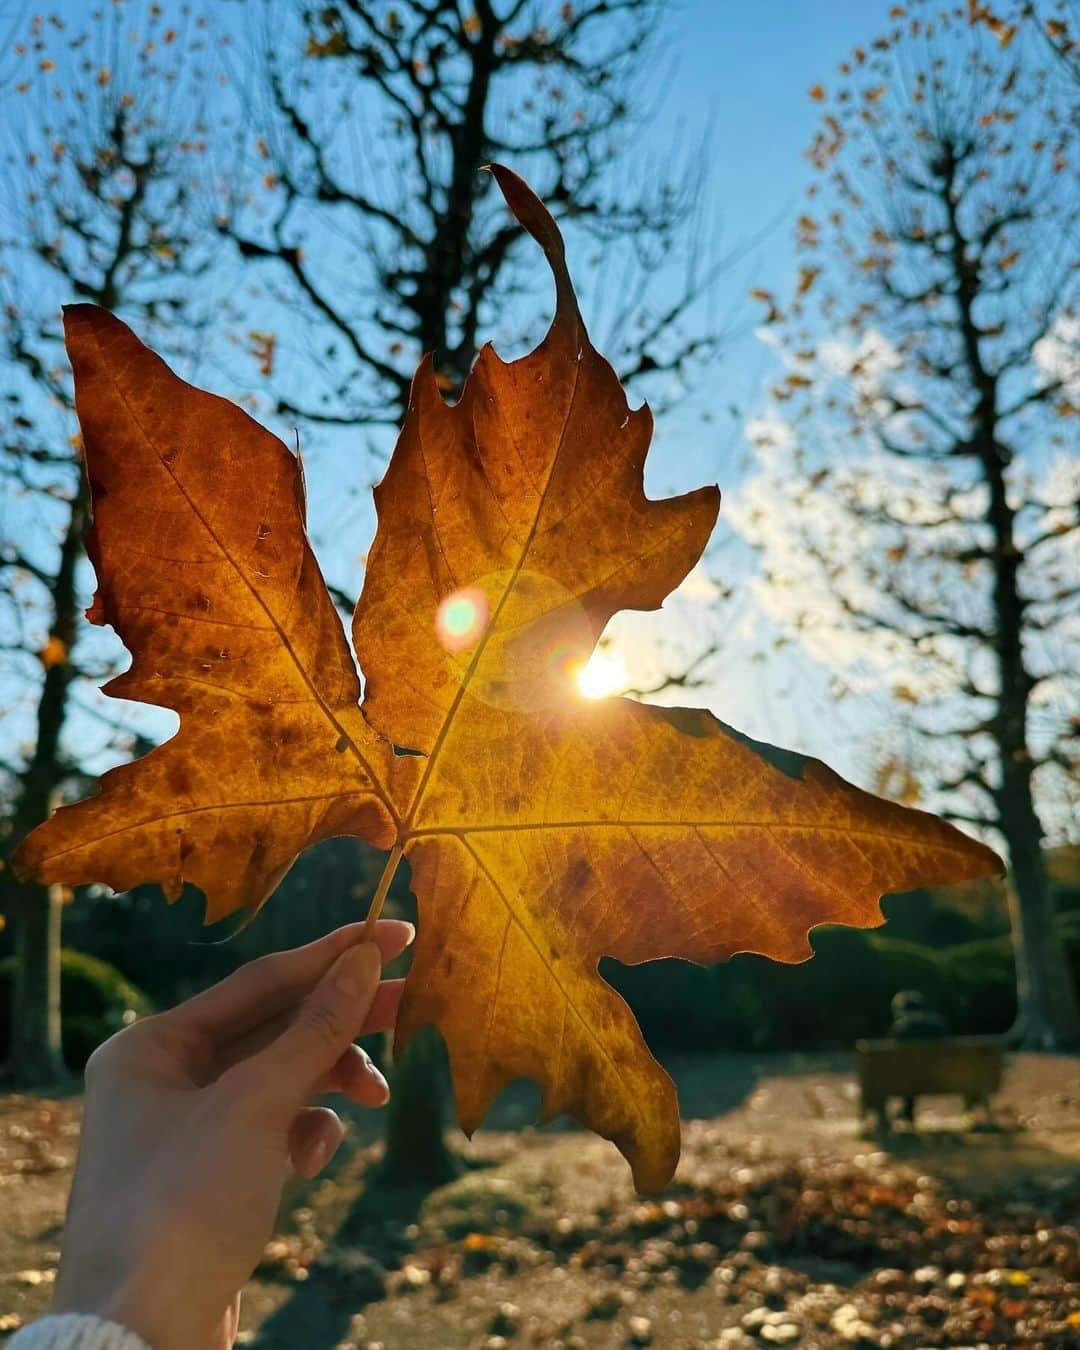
[54,919,413,1350]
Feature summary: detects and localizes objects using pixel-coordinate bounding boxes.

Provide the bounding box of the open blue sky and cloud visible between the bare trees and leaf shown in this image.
[3,0,918,776]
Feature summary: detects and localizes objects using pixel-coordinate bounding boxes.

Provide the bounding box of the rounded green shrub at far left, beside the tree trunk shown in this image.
[0,948,154,1071]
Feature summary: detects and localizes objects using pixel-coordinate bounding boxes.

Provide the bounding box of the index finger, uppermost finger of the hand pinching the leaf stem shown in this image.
[163,919,416,1037]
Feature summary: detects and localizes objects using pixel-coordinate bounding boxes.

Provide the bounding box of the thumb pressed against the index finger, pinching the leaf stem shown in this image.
[248,942,382,1110]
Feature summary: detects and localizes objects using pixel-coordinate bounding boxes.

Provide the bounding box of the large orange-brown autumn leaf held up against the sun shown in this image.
[19,169,1000,1189]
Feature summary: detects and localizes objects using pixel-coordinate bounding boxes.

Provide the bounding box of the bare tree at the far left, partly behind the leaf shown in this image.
[0,3,236,1084]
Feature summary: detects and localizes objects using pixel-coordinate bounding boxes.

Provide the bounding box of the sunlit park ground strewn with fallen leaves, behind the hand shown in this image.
[0,1056,1080,1350]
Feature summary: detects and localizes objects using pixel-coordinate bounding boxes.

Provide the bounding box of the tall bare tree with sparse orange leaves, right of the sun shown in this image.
[744,3,1080,1049]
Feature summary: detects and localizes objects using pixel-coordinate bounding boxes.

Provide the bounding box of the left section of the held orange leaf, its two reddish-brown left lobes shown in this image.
[13,305,394,919]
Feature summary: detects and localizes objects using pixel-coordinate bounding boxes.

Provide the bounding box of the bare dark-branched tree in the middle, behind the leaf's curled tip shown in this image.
[223,0,721,1181]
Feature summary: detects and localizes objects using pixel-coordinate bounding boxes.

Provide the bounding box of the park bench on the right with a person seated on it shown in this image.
[855,1035,1002,1129]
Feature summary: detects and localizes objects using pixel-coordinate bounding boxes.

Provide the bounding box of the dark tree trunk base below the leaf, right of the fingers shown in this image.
[379,1026,462,1191]
